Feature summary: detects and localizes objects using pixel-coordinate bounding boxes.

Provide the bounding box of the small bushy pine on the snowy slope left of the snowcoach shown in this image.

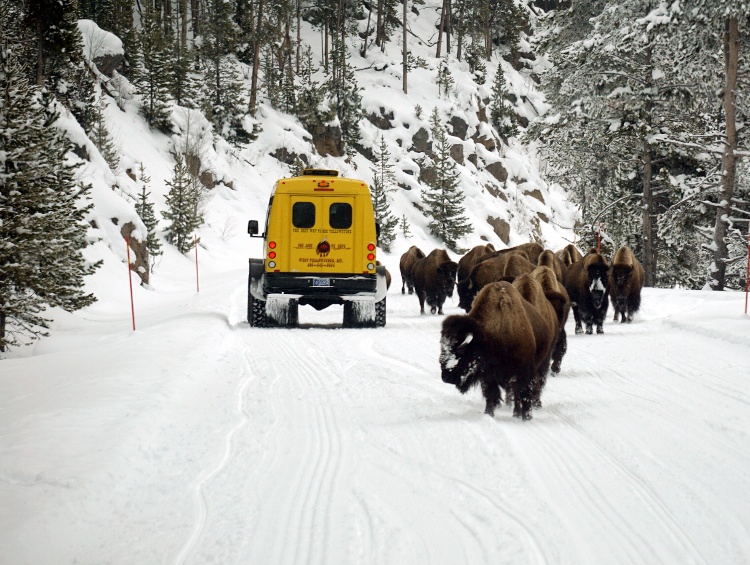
[162,155,203,253]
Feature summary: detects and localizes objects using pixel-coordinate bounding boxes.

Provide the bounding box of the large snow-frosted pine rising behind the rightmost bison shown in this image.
[534,0,708,286]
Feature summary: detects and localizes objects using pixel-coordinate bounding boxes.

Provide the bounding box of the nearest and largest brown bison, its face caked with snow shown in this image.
[440,281,553,420]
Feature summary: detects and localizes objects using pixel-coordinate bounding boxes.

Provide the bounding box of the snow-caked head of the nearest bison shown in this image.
[440,315,482,393]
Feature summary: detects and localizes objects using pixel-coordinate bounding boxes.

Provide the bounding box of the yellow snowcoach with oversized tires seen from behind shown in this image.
[247,169,386,327]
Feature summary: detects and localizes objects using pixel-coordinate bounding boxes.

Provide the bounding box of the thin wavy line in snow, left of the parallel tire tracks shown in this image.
[175,346,255,565]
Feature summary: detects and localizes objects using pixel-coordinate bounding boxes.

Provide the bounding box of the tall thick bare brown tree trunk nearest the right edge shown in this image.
[710,16,739,290]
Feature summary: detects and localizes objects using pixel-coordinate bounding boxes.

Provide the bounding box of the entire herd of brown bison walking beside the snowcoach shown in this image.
[399,243,644,420]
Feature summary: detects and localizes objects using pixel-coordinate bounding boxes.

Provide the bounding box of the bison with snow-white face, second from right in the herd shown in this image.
[565,250,609,334]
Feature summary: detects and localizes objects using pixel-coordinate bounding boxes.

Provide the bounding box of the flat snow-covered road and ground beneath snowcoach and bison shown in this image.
[0,259,750,565]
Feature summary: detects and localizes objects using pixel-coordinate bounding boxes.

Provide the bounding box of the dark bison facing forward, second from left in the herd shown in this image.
[411,249,458,314]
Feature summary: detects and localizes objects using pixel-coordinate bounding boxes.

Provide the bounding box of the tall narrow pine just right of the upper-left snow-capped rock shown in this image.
[132,2,173,133]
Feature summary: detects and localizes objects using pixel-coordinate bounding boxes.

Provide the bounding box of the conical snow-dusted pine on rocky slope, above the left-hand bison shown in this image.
[422,108,472,253]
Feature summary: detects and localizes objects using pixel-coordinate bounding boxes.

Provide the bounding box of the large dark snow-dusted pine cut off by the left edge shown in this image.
[0,45,96,351]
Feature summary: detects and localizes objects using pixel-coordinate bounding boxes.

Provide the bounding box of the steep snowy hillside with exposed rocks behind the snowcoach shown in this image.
[61,5,577,334]
